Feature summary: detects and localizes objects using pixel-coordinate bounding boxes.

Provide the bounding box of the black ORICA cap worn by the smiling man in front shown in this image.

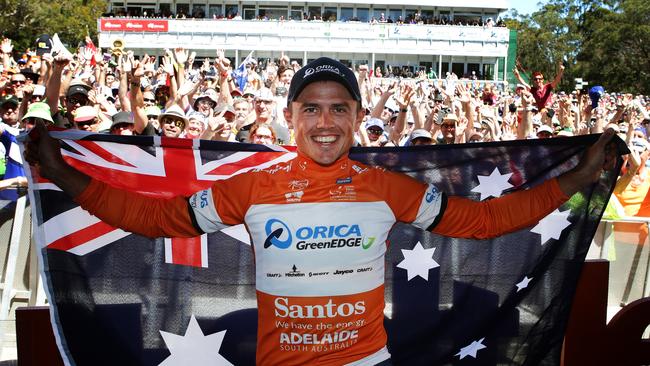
[287,57,361,105]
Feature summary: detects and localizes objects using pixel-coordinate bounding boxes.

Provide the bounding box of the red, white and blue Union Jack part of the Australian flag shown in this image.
[34,132,295,267]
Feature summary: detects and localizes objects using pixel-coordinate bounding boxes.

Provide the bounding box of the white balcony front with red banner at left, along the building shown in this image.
[98,18,509,58]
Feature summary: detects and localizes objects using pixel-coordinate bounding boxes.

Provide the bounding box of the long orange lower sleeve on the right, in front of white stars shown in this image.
[431,178,569,239]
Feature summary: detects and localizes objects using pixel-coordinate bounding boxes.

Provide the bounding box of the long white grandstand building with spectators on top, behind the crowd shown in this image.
[98,0,516,80]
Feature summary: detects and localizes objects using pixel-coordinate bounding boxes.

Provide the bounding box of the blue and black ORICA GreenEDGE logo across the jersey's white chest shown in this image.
[264,219,375,250]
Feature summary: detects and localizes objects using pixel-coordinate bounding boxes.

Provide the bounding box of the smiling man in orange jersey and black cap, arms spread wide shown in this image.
[27,58,615,365]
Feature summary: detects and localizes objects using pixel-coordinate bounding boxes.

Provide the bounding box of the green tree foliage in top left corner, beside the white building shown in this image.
[0,0,107,51]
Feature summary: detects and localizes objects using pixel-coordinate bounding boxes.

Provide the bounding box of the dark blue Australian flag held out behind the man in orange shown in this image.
[20,132,620,365]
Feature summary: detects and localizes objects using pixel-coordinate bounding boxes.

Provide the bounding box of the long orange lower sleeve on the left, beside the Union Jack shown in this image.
[75,179,201,238]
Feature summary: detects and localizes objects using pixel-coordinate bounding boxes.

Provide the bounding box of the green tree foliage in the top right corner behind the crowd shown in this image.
[506,0,650,94]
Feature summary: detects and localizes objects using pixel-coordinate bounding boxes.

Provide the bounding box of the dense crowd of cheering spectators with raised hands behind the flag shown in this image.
[0,39,650,206]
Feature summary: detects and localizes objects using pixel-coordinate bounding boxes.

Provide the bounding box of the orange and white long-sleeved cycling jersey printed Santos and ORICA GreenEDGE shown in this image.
[76,154,567,365]
